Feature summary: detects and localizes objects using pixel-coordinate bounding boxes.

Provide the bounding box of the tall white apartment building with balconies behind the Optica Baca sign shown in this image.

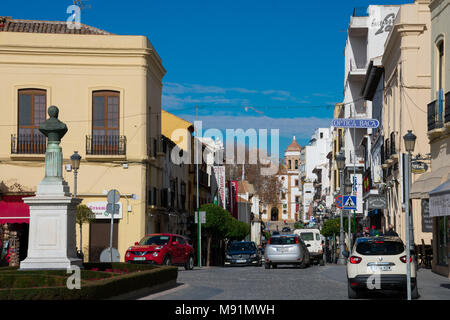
[343,5,399,214]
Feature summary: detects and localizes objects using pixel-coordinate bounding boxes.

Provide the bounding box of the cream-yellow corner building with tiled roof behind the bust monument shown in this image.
[0,18,166,261]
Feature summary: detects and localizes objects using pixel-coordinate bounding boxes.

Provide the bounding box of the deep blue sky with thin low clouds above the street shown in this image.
[0,0,413,157]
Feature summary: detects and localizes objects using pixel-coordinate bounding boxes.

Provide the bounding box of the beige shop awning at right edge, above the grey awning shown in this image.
[410,166,450,199]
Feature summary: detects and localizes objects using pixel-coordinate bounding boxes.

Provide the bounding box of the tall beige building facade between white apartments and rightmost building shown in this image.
[382,0,432,244]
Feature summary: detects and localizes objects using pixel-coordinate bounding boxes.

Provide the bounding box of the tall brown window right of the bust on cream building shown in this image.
[92,91,120,154]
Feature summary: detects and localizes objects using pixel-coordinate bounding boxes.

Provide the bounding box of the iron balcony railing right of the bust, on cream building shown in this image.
[86,135,127,156]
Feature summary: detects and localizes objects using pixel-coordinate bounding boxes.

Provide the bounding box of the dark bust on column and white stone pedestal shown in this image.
[20,106,83,270]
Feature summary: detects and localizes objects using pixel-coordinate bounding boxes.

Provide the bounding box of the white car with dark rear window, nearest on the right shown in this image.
[343,236,419,299]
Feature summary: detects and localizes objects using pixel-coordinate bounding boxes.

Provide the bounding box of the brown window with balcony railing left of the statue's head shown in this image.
[16,89,47,153]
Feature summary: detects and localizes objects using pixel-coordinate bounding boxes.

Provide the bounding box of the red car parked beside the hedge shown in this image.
[125,233,194,270]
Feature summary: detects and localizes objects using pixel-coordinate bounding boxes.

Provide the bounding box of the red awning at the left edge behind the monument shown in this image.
[0,196,30,223]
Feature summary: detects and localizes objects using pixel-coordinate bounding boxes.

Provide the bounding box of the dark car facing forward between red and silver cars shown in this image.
[225,241,261,266]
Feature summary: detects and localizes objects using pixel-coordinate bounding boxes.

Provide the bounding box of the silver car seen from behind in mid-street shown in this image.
[264,234,311,269]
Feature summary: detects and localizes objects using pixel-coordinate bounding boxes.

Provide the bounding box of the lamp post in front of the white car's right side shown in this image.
[403,130,416,300]
